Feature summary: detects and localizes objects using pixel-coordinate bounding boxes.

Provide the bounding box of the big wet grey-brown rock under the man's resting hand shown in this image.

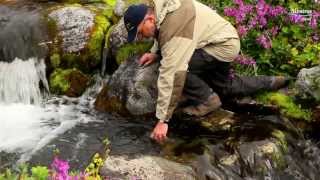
[95,56,159,116]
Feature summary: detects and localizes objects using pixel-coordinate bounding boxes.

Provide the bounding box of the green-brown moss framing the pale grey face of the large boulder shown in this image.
[45,4,113,72]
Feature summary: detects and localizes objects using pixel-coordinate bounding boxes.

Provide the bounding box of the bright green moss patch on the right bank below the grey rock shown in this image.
[257,92,311,121]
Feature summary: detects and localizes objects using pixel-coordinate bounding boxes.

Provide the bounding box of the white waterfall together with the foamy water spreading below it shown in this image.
[0,58,103,162]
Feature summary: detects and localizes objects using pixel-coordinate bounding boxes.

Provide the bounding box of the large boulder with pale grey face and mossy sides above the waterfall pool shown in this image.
[48,5,110,72]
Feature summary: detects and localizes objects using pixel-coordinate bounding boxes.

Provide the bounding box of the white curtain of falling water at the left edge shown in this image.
[0,58,49,104]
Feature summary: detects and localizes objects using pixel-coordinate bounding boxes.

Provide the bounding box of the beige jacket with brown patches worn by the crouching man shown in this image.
[153,0,240,120]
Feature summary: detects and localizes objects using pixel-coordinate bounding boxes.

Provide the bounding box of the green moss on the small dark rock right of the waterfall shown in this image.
[50,68,75,94]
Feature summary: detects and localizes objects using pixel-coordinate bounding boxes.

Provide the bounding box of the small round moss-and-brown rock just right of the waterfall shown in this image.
[50,68,89,97]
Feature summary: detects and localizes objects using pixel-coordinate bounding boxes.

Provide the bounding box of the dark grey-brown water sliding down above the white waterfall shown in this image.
[0,2,48,62]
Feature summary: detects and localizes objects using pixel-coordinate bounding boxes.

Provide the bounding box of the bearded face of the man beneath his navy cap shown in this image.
[137,14,156,40]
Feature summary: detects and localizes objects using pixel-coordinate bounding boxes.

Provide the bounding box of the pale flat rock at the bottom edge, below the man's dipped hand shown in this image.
[101,155,196,180]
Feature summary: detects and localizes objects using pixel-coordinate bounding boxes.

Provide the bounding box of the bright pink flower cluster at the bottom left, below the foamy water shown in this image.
[51,157,70,180]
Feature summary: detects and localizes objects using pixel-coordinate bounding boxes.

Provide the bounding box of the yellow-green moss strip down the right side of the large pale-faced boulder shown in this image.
[87,15,110,64]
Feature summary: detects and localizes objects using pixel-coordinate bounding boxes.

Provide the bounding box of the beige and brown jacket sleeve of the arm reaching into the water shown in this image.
[156,36,196,121]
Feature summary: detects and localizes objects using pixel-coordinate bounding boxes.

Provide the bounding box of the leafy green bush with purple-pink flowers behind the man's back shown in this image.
[220,0,320,76]
